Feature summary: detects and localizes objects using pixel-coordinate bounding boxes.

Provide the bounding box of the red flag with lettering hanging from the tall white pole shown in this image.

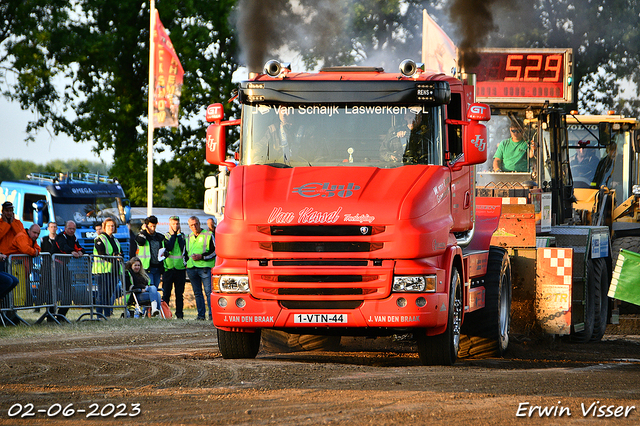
[153,11,184,128]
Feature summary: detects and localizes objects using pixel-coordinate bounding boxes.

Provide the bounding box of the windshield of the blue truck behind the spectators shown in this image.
[53,197,124,226]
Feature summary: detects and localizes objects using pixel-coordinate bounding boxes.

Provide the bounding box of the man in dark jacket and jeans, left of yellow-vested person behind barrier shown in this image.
[54,220,85,315]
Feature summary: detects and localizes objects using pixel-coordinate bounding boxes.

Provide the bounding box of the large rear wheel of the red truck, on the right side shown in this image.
[462,247,511,357]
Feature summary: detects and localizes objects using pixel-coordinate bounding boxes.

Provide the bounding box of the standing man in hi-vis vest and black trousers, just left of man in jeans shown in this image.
[162,216,186,319]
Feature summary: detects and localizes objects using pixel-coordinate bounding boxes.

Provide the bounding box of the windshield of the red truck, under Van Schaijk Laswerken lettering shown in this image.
[242,105,443,168]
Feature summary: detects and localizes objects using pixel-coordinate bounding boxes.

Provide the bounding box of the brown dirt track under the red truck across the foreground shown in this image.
[0,320,640,425]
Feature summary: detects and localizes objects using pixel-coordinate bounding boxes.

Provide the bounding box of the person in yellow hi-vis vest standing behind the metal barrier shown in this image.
[92,218,122,318]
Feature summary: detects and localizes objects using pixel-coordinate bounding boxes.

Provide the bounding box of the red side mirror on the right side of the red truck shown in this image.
[453,104,491,170]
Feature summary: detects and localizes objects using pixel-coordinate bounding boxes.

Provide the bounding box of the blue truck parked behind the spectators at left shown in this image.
[0,173,130,260]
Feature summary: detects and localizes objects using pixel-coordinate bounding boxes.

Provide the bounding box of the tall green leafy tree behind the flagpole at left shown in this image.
[3,0,235,207]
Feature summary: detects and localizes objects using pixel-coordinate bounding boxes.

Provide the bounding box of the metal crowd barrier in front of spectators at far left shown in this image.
[0,253,126,325]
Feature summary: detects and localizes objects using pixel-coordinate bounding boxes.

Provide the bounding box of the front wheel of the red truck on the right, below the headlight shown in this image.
[416,267,462,365]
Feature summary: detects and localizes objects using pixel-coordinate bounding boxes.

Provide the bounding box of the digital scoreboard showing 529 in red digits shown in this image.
[466,48,573,104]
